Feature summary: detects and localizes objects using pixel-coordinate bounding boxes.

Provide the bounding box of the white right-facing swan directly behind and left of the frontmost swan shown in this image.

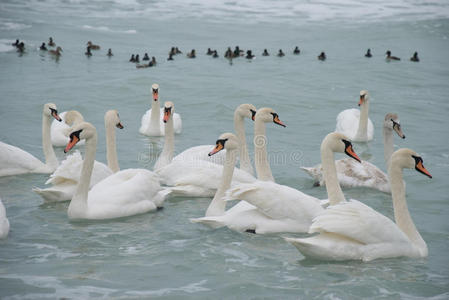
[211,135,359,233]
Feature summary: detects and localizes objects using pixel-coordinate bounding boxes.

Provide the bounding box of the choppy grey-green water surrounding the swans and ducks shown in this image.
[0,0,449,299]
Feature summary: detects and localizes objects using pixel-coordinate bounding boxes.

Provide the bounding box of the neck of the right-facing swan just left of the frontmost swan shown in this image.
[321,141,346,205]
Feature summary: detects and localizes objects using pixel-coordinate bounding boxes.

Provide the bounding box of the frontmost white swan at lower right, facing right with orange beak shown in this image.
[286,149,432,261]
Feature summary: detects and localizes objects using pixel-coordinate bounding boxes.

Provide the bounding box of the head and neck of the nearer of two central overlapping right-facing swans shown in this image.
[254,107,286,182]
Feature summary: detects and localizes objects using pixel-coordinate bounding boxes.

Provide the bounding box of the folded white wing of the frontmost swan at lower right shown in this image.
[309,200,410,244]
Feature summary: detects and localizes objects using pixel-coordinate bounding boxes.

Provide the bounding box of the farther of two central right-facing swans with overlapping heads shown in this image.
[173,104,256,175]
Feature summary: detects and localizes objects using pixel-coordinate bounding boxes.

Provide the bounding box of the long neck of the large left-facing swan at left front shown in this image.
[68,133,97,218]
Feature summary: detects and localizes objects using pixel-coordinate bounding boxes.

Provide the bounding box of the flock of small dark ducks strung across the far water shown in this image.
[12,37,419,64]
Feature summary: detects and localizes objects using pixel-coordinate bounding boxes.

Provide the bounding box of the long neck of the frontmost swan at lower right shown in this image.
[388,164,427,253]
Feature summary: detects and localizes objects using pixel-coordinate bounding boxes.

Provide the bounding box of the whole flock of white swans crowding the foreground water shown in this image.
[0,84,432,261]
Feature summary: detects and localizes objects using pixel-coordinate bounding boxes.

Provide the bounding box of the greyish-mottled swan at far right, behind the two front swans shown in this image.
[301,113,405,193]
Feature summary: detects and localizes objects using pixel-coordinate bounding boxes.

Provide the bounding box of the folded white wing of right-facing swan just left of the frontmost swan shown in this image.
[227,180,322,222]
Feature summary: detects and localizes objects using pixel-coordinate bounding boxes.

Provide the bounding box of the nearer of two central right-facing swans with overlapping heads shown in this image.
[155,108,285,197]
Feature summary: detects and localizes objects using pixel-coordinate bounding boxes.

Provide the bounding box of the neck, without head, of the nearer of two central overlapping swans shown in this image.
[254,118,274,182]
